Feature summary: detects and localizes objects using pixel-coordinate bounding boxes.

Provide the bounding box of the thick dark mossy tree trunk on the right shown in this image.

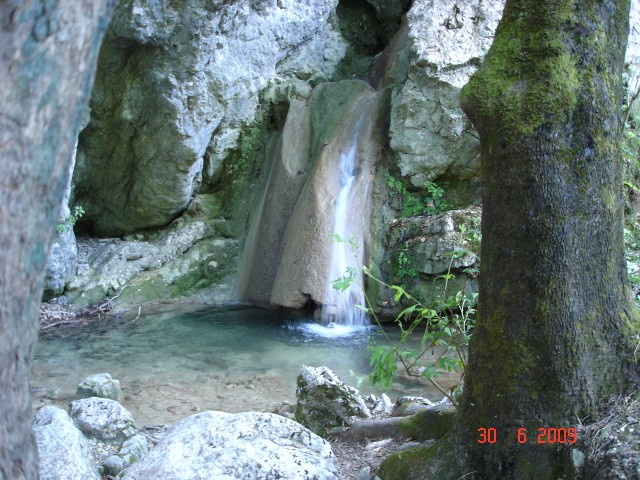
[461,0,637,479]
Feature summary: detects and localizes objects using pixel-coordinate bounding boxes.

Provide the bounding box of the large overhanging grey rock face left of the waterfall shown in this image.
[75,0,346,235]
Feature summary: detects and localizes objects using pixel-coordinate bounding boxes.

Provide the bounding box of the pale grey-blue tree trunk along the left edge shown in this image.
[0,0,115,480]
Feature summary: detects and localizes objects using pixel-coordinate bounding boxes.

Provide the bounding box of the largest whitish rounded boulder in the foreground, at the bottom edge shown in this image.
[121,411,337,480]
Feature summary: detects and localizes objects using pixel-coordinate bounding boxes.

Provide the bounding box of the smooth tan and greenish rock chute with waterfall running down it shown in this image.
[238,80,384,335]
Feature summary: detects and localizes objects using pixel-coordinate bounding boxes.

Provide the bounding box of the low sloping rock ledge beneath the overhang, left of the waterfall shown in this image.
[66,194,239,308]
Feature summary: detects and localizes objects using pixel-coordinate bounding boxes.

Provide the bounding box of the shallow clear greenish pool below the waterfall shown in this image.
[32,305,460,425]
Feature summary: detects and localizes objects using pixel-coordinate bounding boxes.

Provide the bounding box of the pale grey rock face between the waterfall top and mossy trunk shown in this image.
[389,0,504,187]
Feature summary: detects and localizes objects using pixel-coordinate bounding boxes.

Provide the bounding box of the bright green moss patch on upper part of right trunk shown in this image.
[461,2,580,142]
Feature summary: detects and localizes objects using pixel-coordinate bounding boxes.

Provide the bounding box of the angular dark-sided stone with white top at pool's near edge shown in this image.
[295,365,371,436]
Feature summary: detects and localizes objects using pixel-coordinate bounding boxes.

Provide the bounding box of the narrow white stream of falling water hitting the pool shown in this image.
[319,97,372,328]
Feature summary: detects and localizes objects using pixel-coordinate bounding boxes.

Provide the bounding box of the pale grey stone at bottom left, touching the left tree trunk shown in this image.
[33,406,101,480]
